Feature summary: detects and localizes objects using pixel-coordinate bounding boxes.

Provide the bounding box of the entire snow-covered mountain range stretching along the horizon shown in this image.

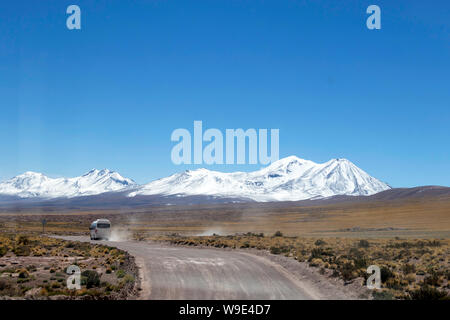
[0,156,390,202]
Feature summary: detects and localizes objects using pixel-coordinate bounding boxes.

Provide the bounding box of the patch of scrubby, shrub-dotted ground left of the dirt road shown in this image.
[0,233,136,299]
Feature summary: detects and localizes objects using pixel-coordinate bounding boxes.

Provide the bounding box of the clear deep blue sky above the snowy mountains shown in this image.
[0,0,450,187]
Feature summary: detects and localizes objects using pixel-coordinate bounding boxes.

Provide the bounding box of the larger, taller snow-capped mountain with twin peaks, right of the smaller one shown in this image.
[129,156,390,201]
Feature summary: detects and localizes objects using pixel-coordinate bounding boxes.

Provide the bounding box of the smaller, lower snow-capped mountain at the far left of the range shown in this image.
[0,169,136,199]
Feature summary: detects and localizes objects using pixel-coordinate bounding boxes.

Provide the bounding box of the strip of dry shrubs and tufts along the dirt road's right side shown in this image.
[156,232,450,300]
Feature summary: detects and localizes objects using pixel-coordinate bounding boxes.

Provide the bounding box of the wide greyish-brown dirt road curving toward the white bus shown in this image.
[62,236,318,299]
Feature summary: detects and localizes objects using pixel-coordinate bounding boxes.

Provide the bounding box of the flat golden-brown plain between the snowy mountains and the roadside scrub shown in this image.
[0,189,450,239]
